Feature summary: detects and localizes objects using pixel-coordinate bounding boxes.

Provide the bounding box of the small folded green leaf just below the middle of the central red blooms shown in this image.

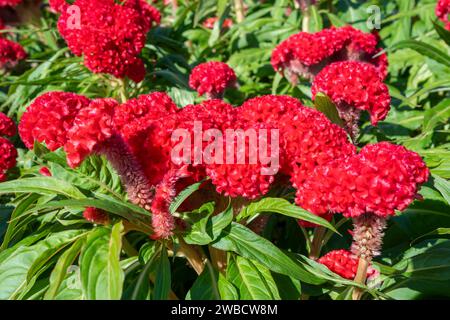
[184,206,233,245]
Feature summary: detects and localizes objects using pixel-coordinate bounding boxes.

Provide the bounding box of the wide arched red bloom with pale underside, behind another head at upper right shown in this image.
[271,26,387,83]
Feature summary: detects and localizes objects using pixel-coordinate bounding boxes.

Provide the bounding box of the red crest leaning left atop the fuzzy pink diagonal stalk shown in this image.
[64,99,118,167]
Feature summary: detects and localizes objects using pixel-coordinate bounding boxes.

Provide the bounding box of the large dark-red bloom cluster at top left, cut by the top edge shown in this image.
[55,0,160,82]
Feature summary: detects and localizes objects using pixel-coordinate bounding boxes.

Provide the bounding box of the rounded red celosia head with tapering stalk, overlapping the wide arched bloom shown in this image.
[311,61,391,139]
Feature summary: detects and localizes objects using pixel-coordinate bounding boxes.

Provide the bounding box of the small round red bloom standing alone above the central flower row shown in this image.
[189,61,236,99]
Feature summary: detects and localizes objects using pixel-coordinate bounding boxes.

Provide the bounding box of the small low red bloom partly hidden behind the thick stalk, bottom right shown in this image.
[318,249,379,280]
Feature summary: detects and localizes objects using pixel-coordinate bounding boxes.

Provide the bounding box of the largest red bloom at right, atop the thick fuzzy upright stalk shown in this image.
[294,142,429,217]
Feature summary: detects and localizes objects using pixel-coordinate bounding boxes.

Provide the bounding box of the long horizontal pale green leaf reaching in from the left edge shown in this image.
[0,177,85,199]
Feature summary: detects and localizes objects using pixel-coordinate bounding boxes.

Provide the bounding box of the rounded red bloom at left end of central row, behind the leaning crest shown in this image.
[19,92,89,151]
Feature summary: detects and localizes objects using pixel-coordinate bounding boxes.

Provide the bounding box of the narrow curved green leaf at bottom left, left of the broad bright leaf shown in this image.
[44,238,85,300]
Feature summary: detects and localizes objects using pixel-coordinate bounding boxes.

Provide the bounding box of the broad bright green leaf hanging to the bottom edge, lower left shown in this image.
[80,221,124,300]
